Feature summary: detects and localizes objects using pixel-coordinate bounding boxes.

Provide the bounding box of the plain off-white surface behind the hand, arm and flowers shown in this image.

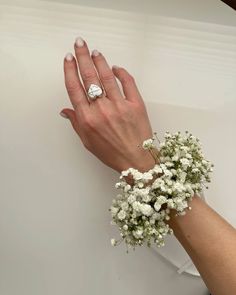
[0,0,236,295]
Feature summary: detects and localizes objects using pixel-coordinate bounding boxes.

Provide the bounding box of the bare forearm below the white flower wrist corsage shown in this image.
[168,196,236,295]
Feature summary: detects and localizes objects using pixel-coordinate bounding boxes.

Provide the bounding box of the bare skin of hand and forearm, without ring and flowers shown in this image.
[61,40,236,295]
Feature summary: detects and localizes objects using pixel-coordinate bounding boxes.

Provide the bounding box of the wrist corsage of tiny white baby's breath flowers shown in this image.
[109,131,213,252]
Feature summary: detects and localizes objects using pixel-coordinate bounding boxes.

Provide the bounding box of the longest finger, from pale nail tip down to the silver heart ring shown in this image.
[75,37,102,99]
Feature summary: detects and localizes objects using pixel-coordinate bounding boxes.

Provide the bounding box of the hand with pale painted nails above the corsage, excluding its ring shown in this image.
[61,38,155,173]
